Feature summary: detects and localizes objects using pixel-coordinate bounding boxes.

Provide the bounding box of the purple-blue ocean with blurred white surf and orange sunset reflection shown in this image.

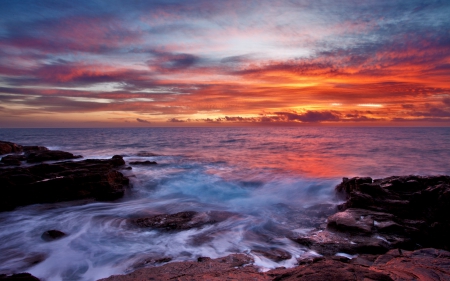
[0,127,450,281]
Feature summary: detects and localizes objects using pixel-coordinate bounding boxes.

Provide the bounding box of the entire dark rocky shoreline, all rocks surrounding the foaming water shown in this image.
[0,141,450,280]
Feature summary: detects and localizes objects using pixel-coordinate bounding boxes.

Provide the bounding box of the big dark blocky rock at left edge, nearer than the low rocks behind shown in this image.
[0,156,129,211]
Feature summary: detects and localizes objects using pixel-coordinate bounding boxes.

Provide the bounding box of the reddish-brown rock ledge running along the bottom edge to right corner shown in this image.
[101,249,450,281]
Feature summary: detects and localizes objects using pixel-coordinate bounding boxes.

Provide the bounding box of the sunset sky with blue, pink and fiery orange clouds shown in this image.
[0,0,450,128]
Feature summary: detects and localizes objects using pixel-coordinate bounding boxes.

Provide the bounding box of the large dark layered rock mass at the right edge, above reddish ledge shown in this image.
[328,176,450,250]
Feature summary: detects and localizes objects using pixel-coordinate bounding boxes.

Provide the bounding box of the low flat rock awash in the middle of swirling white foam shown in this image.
[131,211,234,230]
